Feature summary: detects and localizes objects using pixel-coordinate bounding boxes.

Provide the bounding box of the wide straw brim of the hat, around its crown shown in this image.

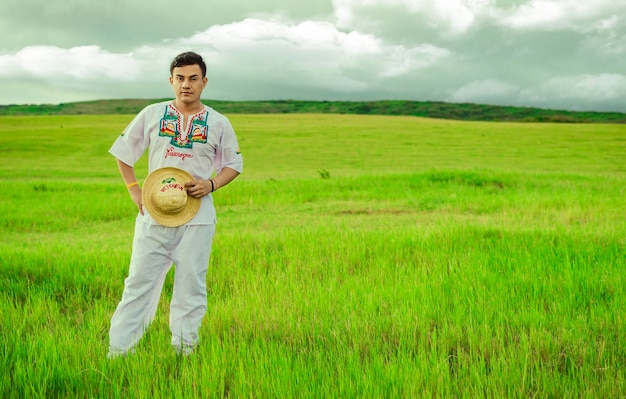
[141,167,201,227]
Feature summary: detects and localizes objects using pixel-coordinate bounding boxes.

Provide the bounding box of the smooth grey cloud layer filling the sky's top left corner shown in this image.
[0,0,332,52]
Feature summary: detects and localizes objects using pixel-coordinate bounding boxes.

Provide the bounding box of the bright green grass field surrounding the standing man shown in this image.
[0,114,626,398]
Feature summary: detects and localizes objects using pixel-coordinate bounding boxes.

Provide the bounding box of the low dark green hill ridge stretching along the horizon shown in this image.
[0,99,626,123]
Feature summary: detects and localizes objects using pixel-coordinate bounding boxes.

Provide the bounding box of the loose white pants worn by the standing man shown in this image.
[109,221,215,354]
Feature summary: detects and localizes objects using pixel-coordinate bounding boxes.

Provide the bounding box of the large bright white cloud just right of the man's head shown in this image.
[176,18,449,92]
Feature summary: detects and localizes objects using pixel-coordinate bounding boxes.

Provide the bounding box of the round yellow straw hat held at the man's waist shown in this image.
[142,168,200,227]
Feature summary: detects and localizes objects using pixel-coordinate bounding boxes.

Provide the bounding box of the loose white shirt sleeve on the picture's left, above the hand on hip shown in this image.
[109,109,150,166]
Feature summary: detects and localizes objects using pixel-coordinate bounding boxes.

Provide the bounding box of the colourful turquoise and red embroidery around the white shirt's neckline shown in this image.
[159,105,209,148]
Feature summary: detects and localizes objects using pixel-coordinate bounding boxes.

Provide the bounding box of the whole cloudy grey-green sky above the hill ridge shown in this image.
[0,0,626,112]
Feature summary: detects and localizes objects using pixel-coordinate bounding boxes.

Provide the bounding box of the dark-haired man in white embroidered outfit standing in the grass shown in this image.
[108,52,243,358]
